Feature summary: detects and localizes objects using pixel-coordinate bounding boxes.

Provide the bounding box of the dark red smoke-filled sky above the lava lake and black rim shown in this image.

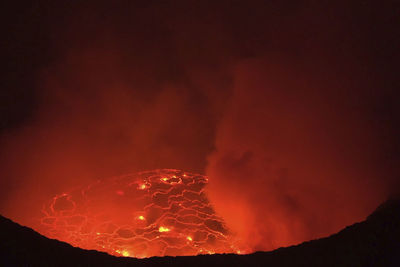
[0,0,400,249]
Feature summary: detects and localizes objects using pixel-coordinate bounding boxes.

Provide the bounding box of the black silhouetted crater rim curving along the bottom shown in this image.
[0,200,400,266]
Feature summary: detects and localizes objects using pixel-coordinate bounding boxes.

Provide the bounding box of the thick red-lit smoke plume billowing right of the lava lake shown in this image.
[207,59,386,250]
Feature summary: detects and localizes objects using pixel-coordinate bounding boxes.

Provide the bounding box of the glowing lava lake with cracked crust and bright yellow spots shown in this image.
[38,169,241,258]
